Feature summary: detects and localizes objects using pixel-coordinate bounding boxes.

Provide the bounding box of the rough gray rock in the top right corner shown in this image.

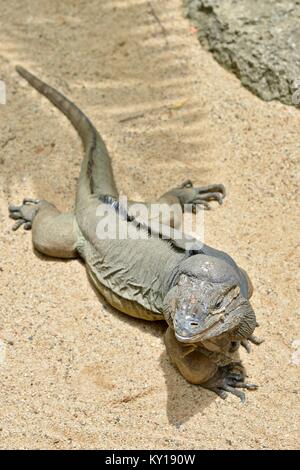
[185,0,300,105]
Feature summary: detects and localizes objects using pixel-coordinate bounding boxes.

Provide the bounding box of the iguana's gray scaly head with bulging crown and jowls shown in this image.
[164,255,256,343]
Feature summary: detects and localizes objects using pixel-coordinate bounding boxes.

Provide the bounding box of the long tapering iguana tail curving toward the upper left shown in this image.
[16,66,118,208]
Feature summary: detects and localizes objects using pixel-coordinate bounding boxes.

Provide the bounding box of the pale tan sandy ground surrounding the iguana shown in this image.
[0,0,300,449]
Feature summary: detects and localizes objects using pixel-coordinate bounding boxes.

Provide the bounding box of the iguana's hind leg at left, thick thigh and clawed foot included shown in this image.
[9,198,77,258]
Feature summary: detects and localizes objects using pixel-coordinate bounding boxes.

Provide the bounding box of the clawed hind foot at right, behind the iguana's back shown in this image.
[180,180,226,212]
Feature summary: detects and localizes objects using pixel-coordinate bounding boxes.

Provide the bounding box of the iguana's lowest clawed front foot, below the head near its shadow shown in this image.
[201,362,257,403]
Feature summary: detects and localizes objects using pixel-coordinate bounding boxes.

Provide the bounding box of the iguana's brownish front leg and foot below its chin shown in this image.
[165,327,257,402]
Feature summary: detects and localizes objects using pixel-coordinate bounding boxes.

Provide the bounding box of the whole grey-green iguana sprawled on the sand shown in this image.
[9,67,260,400]
